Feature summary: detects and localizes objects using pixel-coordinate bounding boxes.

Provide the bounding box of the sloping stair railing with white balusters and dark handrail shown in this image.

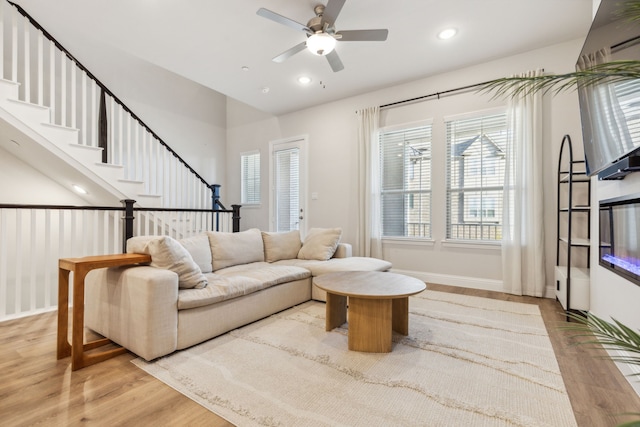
[0,0,213,209]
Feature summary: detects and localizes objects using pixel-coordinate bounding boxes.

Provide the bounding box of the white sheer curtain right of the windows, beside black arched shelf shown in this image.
[502,70,546,297]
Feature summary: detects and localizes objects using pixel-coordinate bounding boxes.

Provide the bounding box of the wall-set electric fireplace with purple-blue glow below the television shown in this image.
[600,194,640,286]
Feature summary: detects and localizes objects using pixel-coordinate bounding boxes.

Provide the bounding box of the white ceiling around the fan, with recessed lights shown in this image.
[14,0,592,114]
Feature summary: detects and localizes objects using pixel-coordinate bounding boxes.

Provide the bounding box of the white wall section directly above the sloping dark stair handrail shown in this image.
[77,44,226,190]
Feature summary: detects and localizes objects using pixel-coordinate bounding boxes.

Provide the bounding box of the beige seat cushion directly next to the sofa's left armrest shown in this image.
[178,273,262,310]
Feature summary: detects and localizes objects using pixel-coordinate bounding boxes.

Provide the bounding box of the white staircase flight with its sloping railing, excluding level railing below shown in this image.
[0,0,212,209]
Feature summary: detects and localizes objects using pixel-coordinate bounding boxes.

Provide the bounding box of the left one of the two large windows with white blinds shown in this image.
[380,124,431,237]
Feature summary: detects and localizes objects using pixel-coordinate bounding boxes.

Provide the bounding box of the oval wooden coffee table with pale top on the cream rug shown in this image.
[314,271,427,353]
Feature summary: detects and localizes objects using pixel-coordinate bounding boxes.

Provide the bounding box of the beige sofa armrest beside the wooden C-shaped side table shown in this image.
[85,266,178,360]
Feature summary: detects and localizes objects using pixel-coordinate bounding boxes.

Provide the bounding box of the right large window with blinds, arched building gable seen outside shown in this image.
[446,113,507,241]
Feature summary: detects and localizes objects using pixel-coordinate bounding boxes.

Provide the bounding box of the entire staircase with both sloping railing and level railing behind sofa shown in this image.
[0,0,240,321]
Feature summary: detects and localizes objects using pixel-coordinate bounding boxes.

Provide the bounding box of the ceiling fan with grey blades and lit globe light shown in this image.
[257,0,389,72]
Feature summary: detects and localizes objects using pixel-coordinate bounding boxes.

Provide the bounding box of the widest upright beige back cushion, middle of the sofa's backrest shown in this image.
[207,228,264,271]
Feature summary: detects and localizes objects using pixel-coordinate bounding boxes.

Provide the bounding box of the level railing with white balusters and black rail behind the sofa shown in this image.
[0,200,240,322]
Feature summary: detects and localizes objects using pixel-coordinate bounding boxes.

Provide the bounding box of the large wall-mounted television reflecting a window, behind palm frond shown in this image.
[576,0,640,179]
